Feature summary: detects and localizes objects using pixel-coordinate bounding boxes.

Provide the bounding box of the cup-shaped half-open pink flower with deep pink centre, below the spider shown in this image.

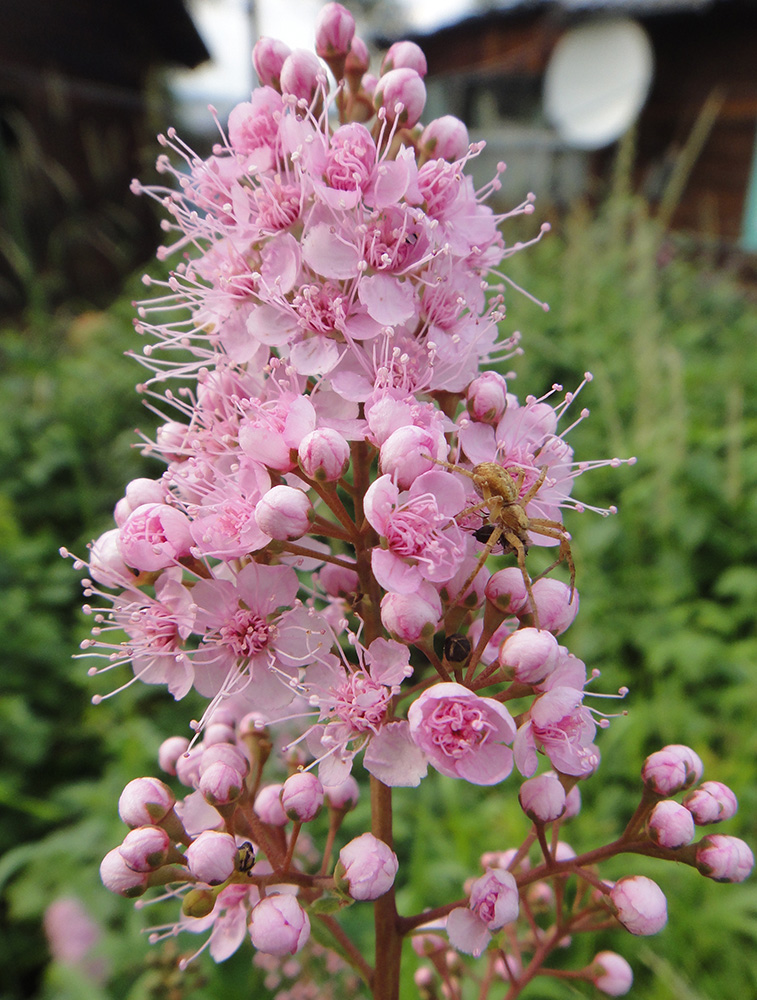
[407,683,515,785]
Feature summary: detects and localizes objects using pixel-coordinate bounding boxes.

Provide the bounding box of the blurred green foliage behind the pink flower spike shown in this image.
[0,182,757,1000]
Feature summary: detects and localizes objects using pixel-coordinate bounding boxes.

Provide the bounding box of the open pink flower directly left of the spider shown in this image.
[364,471,465,594]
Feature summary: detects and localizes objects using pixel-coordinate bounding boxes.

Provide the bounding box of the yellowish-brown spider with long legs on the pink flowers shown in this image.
[435,459,576,628]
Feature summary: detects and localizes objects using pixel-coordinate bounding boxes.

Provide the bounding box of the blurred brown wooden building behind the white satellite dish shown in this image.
[416,0,757,250]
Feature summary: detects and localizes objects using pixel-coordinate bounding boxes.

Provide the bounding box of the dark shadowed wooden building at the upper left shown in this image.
[0,0,208,311]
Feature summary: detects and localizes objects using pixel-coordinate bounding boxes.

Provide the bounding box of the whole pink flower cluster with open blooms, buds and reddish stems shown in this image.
[66,3,751,997]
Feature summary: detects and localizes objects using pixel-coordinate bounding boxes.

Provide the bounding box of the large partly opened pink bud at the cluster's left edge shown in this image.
[118,503,194,572]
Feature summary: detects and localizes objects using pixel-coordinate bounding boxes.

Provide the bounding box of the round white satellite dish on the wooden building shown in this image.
[544,18,653,149]
